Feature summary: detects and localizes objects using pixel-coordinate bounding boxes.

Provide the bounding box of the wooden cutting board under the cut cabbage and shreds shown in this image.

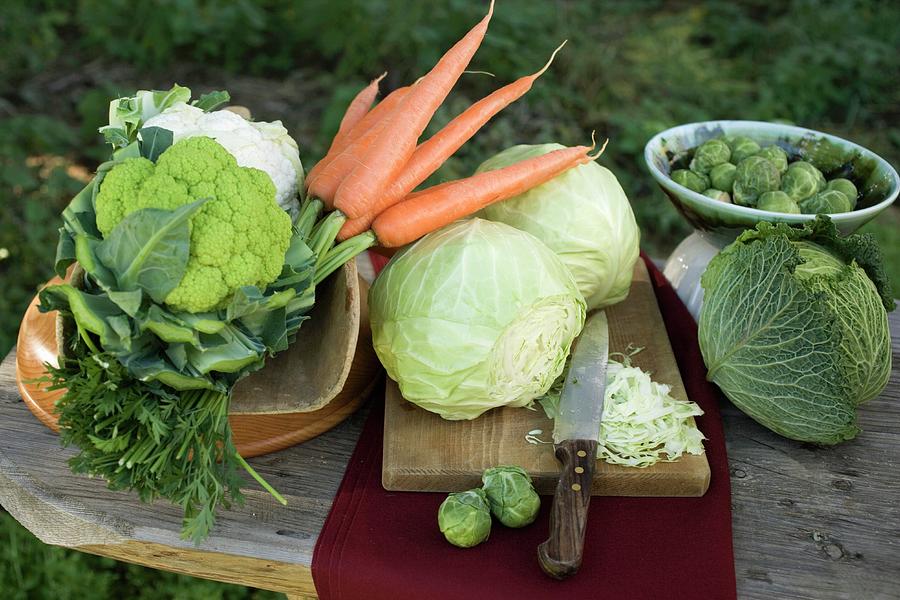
[382,260,710,496]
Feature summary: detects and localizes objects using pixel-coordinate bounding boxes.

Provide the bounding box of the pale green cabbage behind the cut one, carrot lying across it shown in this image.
[477,144,640,309]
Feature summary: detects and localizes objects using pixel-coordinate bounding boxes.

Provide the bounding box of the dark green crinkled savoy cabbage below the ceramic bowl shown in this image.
[698,217,893,444]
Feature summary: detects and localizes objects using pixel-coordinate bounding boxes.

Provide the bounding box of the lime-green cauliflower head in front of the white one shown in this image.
[95,137,291,313]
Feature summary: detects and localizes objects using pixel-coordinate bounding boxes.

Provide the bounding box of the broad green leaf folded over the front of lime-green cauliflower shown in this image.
[97,200,205,303]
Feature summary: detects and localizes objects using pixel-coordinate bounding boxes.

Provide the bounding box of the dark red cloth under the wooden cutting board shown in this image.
[312,257,736,600]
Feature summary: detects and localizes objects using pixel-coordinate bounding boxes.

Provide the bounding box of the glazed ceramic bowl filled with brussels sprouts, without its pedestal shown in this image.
[644,121,900,243]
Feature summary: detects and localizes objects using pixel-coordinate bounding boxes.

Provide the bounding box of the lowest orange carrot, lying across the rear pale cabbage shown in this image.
[372,139,606,248]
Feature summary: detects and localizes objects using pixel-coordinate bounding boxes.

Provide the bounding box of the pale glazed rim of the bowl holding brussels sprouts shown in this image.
[644,119,900,223]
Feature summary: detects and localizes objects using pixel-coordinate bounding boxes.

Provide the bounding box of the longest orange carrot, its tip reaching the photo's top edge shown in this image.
[334,0,494,219]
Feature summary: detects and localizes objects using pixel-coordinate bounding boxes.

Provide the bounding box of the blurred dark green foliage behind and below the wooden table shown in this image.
[0,0,900,598]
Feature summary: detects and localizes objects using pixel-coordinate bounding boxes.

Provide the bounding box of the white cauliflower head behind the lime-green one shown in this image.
[143,102,303,217]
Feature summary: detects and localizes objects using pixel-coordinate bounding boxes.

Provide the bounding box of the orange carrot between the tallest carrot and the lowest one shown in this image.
[338,42,566,240]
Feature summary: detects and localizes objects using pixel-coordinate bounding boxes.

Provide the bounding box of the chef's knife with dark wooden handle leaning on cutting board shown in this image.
[538,311,609,579]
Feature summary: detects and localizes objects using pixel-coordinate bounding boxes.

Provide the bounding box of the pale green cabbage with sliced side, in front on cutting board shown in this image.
[369,219,586,419]
